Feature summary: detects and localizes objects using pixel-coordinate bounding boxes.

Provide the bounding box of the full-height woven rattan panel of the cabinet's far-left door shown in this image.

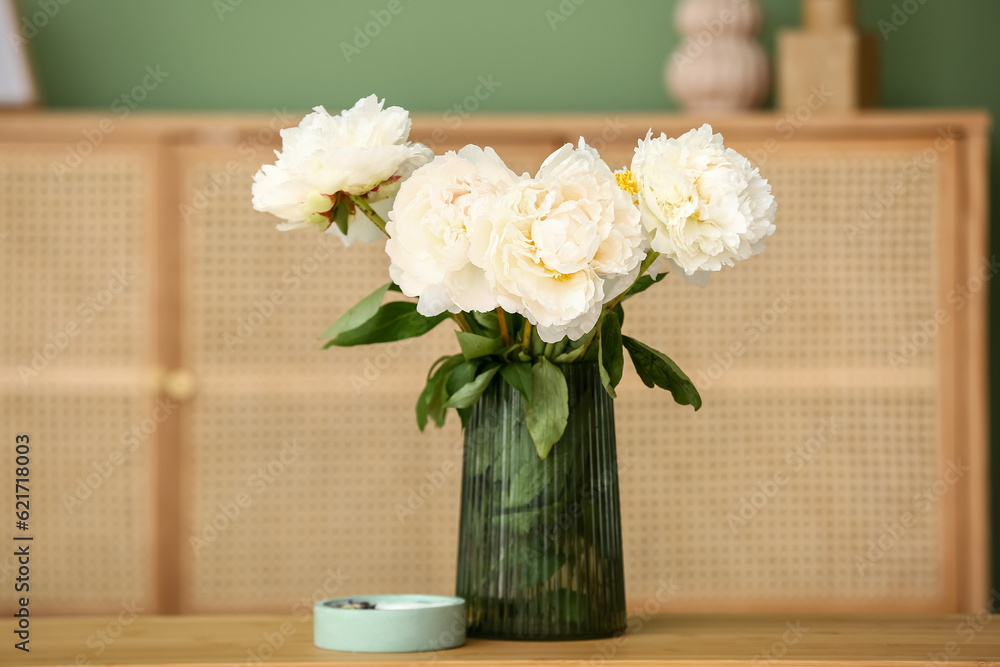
[0,143,157,614]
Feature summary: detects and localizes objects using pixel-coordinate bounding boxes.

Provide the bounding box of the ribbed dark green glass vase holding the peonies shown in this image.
[456,363,626,640]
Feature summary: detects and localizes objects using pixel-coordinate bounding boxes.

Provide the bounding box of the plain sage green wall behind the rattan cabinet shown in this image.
[18,0,1000,600]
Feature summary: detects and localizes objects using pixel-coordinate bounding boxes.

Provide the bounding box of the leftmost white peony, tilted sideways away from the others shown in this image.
[253,95,433,245]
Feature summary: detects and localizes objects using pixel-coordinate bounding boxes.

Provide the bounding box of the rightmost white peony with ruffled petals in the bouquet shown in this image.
[631,125,777,276]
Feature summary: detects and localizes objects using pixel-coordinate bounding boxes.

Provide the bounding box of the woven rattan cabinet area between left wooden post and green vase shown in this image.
[177,143,498,614]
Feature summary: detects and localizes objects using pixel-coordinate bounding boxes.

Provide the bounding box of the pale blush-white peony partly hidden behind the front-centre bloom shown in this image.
[385,146,517,317]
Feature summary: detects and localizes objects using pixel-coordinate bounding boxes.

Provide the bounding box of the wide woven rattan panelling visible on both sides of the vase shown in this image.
[181,142,954,612]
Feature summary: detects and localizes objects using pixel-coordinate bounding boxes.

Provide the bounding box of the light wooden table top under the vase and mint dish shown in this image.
[11,613,1000,667]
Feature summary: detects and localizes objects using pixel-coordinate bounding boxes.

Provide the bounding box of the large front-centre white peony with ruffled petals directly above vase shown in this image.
[470,139,647,343]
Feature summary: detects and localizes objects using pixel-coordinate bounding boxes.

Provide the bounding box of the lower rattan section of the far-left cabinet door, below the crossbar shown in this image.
[0,392,156,615]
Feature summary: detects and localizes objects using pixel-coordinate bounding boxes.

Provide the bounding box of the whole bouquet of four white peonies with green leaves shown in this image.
[253,95,776,459]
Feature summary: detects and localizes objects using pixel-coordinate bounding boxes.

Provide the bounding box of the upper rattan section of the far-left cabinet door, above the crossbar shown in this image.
[0,144,156,370]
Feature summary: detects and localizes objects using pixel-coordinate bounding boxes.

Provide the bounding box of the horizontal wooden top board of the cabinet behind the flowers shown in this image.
[0,109,990,143]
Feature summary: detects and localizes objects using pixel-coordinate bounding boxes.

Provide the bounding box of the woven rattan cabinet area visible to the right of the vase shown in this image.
[616,140,974,611]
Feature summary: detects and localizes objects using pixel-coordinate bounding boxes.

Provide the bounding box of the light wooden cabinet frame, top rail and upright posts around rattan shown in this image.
[0,111,992,613]
